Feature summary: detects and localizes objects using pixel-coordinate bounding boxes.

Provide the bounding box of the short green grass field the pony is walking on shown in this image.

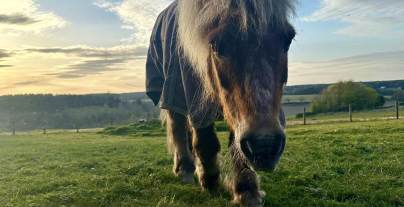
[0,120,404,207]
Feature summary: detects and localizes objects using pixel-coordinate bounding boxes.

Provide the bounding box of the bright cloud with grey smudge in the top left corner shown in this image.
[0,0,67,35]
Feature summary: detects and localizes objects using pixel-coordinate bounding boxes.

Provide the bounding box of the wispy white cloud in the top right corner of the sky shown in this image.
[303,0,404,36]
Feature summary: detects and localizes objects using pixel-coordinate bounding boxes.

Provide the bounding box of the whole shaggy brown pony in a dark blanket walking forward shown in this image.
[146,0,295,206]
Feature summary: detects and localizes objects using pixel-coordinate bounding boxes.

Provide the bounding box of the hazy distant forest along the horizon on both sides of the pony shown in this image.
[0,80,404,132]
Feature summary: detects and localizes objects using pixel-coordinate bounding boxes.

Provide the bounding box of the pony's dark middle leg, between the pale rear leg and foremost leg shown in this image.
[192,124,220,190]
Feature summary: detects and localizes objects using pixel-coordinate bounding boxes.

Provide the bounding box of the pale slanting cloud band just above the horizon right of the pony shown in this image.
[289,51,404,85]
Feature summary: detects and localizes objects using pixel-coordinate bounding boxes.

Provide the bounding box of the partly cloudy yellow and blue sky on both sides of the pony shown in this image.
[0,0,404,95]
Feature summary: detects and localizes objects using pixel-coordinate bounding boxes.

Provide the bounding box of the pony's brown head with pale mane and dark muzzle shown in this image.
[178,0,295,170]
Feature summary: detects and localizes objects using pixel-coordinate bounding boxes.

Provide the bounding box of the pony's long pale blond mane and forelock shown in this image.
[178,0,296,98]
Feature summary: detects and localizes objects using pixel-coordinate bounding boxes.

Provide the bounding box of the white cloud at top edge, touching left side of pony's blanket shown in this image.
[95,0,172,45]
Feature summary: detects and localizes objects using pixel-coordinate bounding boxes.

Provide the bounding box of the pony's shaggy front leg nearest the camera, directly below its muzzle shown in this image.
[225,133,265,207]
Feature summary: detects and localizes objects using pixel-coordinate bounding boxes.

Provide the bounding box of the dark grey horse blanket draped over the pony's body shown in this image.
[146,1,220,128]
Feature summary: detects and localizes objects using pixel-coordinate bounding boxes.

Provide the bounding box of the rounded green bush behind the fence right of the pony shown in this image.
[311,81,385,113]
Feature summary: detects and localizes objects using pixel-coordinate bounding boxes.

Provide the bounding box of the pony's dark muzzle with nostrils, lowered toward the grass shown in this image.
[240,132,286,171]
